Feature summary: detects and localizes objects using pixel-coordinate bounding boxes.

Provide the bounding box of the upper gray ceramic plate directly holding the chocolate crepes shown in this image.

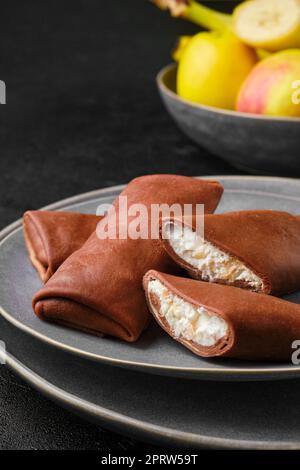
[0,177,300,380]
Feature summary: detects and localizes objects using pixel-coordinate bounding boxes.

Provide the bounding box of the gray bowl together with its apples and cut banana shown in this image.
[155,0,300,175]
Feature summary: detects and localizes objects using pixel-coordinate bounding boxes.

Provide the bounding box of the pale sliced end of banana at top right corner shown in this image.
[233,0,300,52]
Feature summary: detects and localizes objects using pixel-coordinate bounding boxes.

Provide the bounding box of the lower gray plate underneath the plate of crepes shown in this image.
[0,312,300,449]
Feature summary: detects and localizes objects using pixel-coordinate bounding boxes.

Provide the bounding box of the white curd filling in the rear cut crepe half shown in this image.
[165,223,263,291]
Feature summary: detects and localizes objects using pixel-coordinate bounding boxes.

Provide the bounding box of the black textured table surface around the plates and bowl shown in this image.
[0,0,244,452]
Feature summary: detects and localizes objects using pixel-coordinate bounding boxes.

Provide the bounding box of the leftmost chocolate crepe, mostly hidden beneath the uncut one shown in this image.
[23,211,101,282]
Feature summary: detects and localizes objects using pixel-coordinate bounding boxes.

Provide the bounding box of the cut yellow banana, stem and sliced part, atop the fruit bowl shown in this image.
[152,0,300,52]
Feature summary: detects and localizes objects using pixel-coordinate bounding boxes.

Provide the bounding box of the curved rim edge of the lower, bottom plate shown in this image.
[6,346,300,450]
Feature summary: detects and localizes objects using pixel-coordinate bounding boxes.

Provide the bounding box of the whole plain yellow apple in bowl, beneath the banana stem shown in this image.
[177,31,257,109]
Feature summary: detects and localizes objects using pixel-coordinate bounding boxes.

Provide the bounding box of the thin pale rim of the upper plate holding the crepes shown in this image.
[0,175,300,381]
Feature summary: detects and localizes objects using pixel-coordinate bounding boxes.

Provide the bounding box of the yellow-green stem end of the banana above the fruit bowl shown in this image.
[152,0,232,31]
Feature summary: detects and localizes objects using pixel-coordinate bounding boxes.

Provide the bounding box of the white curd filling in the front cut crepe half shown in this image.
[148,279,228,347]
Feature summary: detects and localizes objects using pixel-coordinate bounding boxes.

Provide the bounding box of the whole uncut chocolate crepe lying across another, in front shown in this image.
[33,175,223,342]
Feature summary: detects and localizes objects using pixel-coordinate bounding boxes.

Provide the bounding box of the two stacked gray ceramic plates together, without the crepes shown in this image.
[0,176,300,449]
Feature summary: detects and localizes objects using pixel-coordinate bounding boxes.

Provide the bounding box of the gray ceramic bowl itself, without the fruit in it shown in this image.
[157,64,300,175]
